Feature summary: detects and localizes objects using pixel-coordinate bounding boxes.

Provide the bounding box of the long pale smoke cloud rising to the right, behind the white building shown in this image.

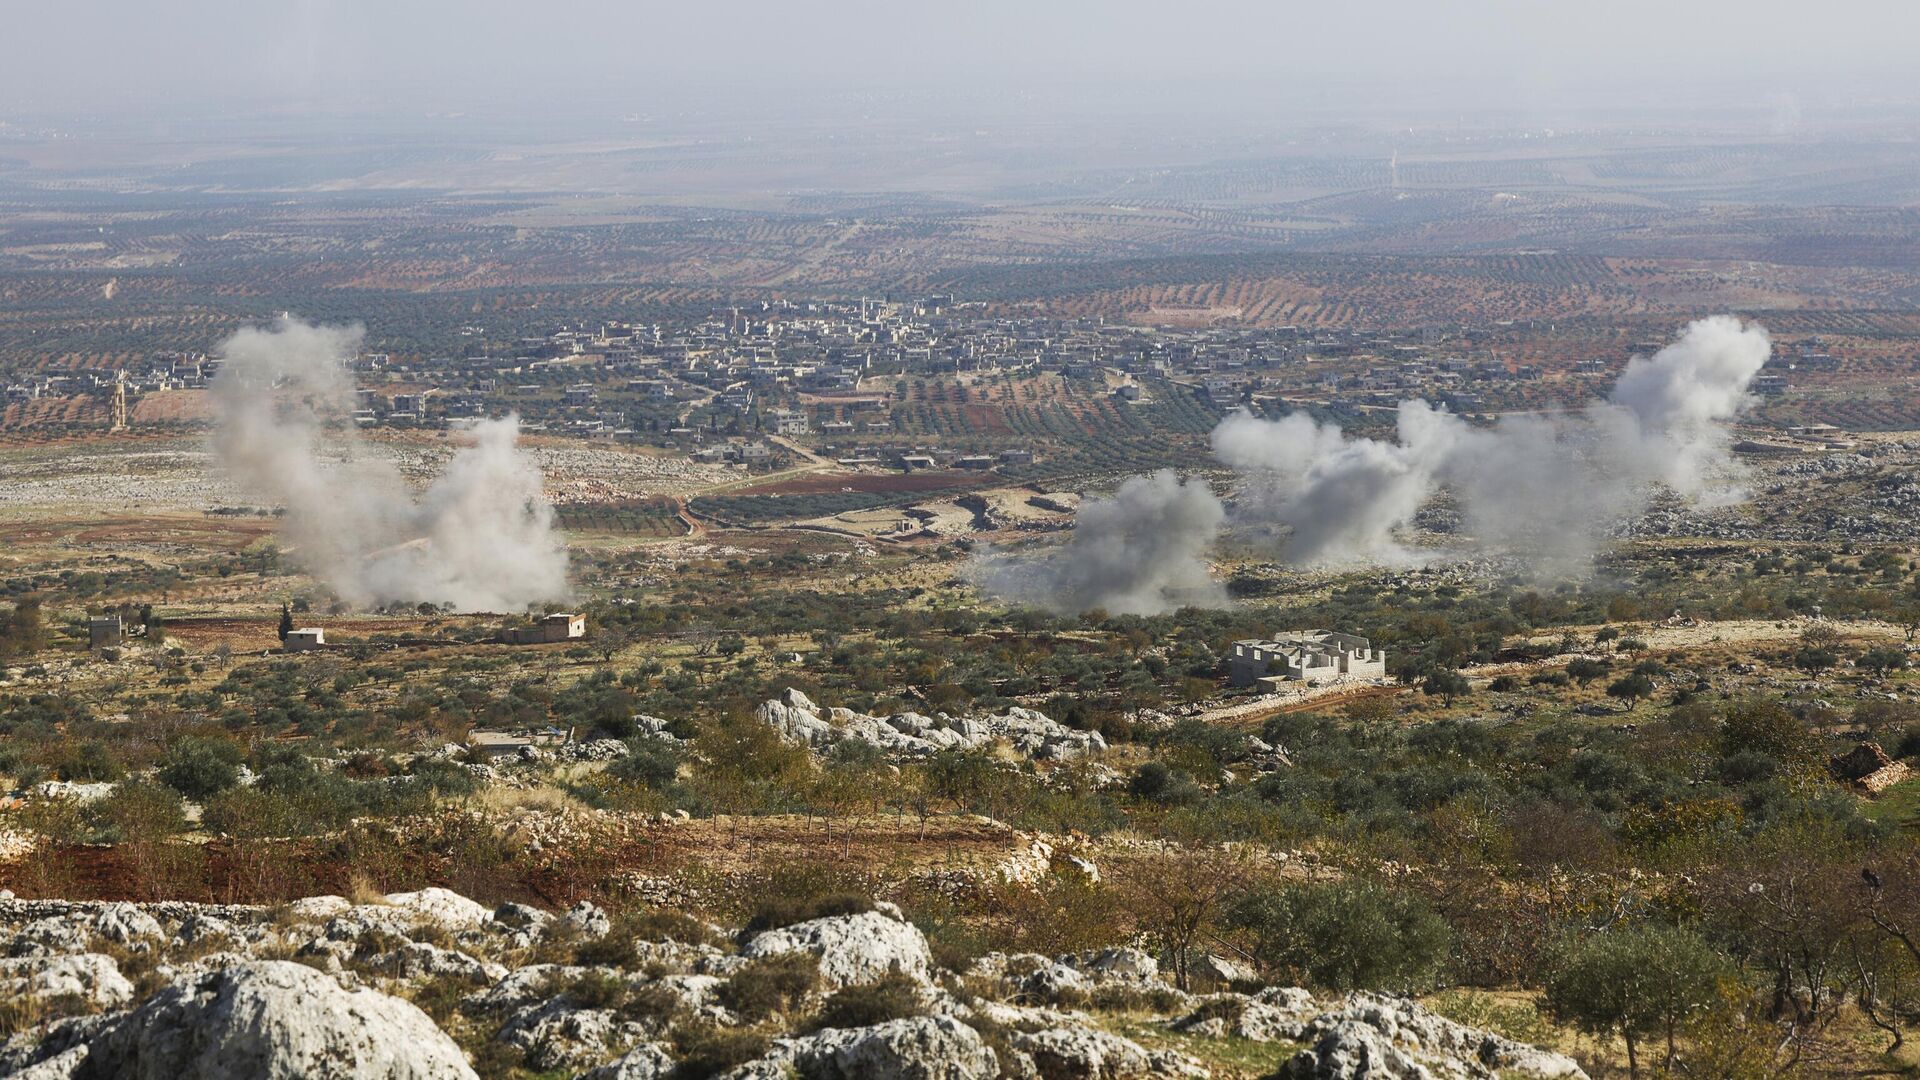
[1213,315,1772,571]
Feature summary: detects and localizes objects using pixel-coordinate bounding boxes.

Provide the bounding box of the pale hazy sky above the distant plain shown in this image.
[0,0,1920,115]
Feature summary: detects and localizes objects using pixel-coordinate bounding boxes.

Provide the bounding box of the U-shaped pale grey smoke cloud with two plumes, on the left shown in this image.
[213,319,568,611]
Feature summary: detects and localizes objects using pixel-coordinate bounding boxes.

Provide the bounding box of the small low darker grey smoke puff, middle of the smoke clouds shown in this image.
[973,469,1227,615]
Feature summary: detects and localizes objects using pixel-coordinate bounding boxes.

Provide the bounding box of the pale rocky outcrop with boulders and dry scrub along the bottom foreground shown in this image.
[0,888,1584,1080]
